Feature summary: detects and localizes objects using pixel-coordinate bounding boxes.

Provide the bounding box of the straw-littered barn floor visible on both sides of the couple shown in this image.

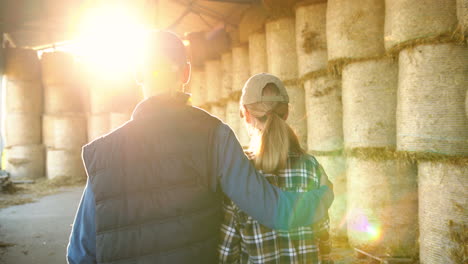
[0,179,373,264]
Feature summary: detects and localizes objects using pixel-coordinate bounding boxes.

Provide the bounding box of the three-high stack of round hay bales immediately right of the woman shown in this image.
[296,1,346,242]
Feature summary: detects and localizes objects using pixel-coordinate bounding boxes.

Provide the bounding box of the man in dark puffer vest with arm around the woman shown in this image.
[67,31,333,263]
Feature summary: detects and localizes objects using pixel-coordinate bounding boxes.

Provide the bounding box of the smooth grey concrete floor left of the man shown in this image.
[0,187,84,264]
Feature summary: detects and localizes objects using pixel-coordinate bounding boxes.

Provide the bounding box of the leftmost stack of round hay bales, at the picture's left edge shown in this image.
[2,48,45,178]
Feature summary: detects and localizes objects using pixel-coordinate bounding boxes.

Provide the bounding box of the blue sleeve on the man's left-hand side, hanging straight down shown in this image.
[67,182,96,264]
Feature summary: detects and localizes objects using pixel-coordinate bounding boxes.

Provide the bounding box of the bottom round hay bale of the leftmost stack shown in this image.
[4,145,45,179]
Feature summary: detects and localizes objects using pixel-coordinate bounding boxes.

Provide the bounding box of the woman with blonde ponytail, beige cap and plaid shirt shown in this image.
[219,73,332,263]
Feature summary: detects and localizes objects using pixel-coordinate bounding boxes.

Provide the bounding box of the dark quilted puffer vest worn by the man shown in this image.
[83,97,221,264]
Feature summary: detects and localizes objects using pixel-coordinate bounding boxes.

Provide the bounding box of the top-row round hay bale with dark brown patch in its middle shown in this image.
[296,2,328,77]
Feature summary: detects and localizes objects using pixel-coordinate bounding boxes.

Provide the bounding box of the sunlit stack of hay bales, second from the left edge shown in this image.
[41,52,87,179]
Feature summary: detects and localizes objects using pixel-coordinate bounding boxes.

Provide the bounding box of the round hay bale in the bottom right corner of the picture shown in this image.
[418,161,468,264]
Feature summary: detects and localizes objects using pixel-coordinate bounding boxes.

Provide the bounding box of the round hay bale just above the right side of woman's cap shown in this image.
[266,17,298,81]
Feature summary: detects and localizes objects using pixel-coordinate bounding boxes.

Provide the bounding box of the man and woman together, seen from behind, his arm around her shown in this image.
[67,31,333,263]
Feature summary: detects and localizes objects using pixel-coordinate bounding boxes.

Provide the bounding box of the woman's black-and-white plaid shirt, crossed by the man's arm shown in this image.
[218,153,332,263]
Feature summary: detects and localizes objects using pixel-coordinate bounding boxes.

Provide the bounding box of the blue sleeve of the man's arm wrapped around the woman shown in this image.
[213,124,333,229]
